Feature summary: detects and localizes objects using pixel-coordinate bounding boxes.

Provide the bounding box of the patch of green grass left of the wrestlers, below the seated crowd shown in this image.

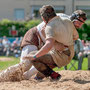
[0,56,19,70]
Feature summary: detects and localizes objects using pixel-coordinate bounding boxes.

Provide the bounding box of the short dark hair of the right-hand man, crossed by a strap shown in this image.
[70,10,87,20]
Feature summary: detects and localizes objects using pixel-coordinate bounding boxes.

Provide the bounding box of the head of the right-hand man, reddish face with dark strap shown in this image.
[70,10,87,28]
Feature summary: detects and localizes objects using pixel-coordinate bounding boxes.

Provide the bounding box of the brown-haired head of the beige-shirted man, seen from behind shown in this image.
[40,5,56,23]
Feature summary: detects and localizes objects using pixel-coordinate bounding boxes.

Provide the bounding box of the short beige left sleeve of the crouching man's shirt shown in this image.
[45,25,55,39]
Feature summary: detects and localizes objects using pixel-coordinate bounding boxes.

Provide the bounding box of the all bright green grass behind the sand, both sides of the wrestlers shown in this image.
[0,56,88,71]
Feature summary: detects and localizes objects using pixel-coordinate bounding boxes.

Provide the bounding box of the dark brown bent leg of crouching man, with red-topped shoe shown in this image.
[32,54,61,80]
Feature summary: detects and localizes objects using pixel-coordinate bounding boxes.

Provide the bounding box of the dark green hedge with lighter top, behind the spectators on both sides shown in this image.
[0,19,90,41]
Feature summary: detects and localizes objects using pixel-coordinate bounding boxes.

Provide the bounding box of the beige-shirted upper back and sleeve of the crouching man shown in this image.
[45,16,75,46]
